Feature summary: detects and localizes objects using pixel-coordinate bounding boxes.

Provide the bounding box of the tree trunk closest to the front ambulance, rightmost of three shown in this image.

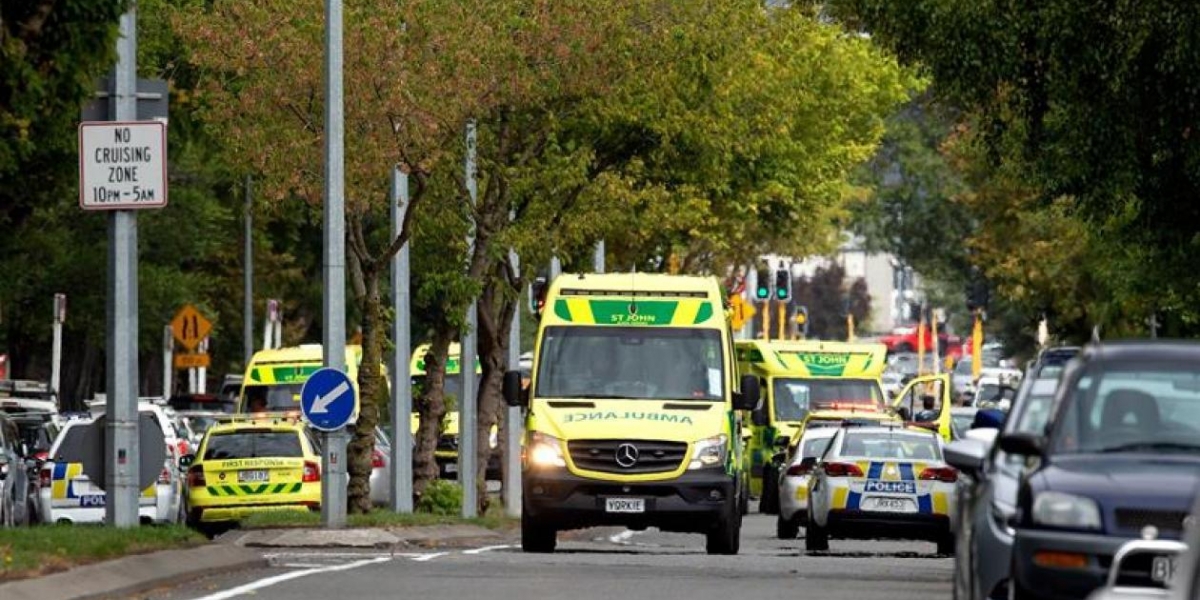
[475,257,516,515]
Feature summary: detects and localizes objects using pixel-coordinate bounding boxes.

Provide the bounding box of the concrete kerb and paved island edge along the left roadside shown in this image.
[0,526,504,600]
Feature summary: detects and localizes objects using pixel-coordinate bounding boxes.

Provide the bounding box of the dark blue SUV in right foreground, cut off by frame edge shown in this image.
[1000,341,1200,599]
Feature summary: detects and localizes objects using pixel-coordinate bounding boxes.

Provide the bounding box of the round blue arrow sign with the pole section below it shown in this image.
[300,367,359,528]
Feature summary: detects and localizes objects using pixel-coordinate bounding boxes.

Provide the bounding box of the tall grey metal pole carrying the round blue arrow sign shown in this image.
[320,0,349,529]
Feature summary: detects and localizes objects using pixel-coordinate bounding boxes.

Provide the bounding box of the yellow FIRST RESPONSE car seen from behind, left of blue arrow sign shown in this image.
[180,419,320,534]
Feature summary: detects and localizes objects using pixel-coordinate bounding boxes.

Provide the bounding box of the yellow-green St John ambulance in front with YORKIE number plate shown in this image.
[504,272,758,554]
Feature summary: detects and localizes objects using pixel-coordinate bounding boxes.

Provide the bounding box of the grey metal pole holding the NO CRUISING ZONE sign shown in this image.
[104,4,142,528]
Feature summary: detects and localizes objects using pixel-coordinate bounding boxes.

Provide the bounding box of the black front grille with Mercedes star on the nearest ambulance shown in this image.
[566,439,688,474]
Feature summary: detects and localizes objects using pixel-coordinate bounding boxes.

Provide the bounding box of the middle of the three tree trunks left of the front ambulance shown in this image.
[410,319,457,496]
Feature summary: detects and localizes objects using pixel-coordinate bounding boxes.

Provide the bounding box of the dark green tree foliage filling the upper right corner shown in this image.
[830,0,1200,338]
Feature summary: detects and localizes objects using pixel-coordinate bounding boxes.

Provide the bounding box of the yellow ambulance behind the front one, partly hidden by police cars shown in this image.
[736,340,895,514]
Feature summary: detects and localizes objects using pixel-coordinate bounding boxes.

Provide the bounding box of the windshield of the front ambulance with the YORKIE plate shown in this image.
[534,326,725,401]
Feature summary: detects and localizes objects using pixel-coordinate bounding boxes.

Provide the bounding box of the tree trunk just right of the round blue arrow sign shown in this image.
[347,265,384,512]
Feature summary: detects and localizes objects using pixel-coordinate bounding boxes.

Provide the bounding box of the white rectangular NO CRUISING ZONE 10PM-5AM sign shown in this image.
[79,121,167,210]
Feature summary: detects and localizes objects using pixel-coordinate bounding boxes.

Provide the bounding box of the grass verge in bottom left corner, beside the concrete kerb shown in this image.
[0,524,205,582]
